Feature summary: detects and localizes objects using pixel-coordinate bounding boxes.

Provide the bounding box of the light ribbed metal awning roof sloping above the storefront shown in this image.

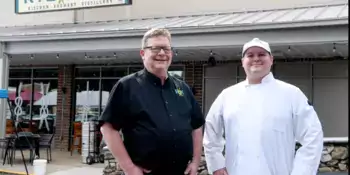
[0,2,349,41]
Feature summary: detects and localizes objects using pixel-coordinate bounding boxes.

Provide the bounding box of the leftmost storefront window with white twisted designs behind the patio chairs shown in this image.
[7,68,58,133]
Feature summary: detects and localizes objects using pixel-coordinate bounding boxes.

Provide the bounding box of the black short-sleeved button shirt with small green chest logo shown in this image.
[100,69,205,169]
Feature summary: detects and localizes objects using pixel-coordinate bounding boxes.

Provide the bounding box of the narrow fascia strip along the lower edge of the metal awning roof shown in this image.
[0,19,349,42]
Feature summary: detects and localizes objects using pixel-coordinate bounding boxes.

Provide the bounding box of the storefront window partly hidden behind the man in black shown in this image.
[74,66,184,122]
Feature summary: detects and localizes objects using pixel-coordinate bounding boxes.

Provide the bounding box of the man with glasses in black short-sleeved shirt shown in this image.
[100,29,205,175]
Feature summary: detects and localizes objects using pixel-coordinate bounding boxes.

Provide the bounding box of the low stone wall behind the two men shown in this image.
[103,143,349,175]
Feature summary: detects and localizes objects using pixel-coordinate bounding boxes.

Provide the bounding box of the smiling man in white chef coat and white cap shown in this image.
[203,38,323,175]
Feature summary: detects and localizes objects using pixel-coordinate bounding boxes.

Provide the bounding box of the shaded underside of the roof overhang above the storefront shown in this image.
[5,25,348,54]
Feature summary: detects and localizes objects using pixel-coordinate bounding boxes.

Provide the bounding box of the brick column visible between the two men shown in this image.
[185,62,203,107]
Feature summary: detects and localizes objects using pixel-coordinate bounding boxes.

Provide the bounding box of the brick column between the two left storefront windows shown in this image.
[54,65,74,150]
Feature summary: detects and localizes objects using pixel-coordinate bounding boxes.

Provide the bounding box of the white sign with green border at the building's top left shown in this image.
[15,0,131,13]
